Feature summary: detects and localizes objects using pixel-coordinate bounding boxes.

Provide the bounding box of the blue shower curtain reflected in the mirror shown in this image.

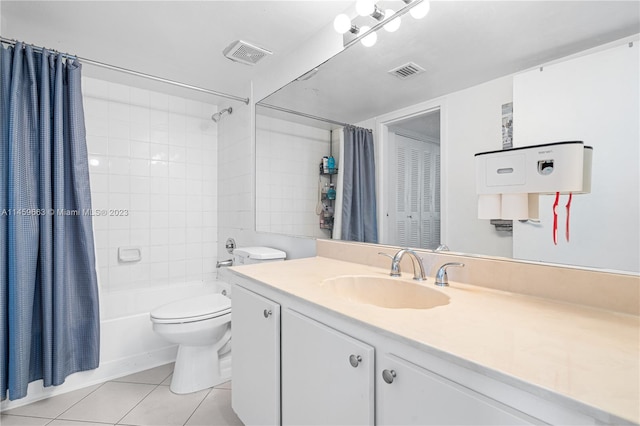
[341,126,378,243]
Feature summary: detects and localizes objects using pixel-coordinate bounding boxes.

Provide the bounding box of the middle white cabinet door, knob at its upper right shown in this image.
[282,309,374,425]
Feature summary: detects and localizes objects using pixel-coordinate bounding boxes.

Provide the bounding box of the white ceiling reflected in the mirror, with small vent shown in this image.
[258,0,640,123]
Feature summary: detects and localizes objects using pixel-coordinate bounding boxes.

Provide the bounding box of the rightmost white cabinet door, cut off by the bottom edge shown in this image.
[376,355,532,425]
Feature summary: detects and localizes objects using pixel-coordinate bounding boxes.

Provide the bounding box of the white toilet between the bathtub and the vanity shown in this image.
[151,247,286,394]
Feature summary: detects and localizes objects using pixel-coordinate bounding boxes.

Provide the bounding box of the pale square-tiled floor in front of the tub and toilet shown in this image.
[0,364,242,426]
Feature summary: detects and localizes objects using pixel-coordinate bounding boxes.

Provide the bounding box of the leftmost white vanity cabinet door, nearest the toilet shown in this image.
[231,286,280,425]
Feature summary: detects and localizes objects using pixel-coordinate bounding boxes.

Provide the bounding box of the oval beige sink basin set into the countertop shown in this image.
[321,275,449,309]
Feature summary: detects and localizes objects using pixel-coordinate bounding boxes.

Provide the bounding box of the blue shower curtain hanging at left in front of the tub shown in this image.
[0,43,100,400]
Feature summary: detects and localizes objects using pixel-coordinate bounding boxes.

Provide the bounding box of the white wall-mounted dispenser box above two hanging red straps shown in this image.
[475,141,593,219]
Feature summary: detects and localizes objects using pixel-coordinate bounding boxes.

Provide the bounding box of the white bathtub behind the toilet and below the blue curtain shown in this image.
[0,281,229,411]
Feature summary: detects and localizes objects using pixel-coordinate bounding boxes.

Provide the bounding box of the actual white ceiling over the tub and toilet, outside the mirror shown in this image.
[0,0,353,103]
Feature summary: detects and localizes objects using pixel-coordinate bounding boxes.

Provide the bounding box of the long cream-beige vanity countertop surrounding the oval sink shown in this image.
[231,257,640,423]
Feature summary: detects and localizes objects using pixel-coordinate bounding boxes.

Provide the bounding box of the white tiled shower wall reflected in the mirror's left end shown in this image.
[256,114,331,238]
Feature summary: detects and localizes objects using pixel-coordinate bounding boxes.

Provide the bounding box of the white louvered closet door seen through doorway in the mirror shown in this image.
[395,135,440,249]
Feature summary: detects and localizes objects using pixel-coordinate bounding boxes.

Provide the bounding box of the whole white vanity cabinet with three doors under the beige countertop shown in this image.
[226,266,624,425]
